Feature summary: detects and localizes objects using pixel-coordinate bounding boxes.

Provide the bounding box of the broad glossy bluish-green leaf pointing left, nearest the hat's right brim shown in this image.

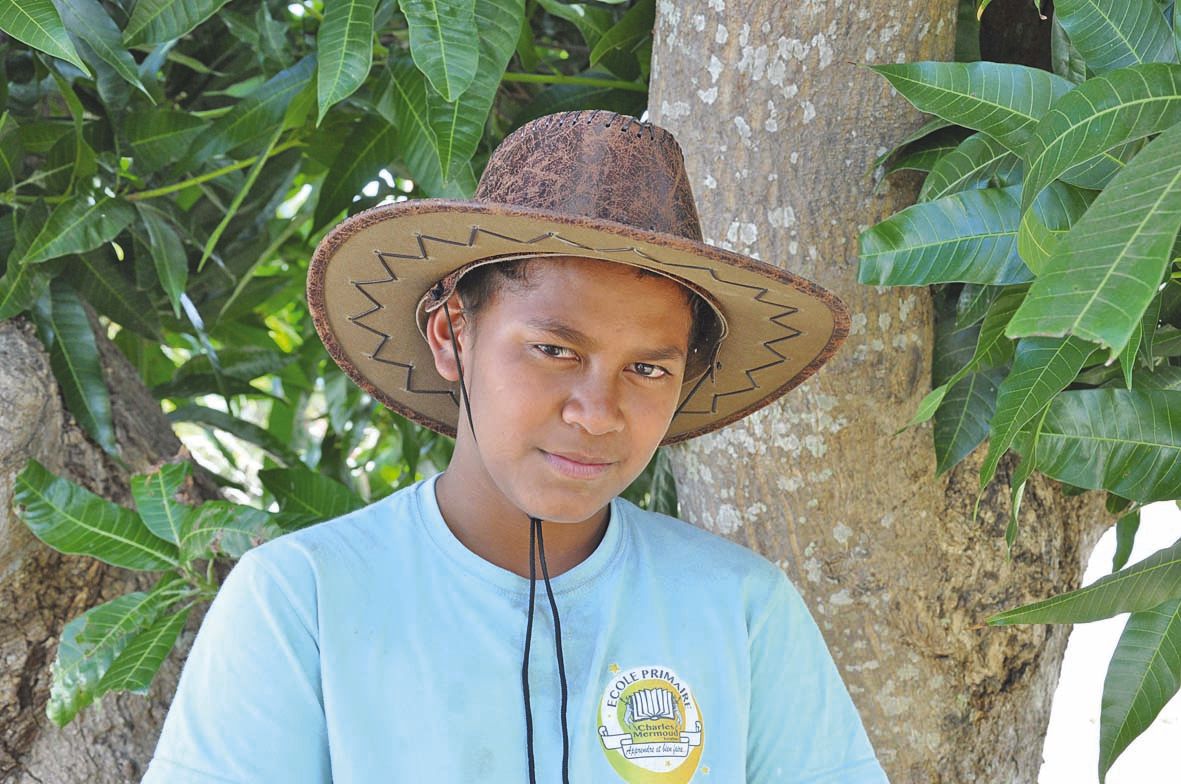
[857,185,1032,286]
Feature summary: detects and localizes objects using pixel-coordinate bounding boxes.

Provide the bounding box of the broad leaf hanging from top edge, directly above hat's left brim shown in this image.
[399,0,477,102]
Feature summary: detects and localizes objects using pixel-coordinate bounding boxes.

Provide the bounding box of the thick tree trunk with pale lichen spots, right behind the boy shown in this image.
[650,0,1108,784]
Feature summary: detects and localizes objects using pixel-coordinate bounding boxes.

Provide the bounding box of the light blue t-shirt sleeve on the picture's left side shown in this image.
[143,550,332,784]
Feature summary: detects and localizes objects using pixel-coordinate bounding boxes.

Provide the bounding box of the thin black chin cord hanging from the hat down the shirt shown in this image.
[443,300,570,784]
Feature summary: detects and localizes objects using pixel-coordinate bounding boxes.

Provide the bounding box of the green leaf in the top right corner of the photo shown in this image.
[1053,0,1176,73]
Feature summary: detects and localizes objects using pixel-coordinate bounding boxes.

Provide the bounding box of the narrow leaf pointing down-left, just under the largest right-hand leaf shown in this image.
[980,338,1095,490]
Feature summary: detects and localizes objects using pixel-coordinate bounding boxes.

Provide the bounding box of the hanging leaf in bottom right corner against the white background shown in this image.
[1100,599,1181,782]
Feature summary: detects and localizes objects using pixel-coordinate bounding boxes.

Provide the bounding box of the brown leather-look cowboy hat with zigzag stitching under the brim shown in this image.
[307,111,849,444]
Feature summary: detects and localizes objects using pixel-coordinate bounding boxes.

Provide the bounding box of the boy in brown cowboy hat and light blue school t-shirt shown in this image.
[145,111,886,784]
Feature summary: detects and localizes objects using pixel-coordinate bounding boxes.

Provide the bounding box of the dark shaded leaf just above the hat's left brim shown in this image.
[313,116,398,226]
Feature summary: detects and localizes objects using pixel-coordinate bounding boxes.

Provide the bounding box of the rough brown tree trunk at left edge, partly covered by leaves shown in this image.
[0,321,208,784]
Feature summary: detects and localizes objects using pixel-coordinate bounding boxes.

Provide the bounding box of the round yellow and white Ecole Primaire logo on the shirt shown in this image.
[599,665,703,784]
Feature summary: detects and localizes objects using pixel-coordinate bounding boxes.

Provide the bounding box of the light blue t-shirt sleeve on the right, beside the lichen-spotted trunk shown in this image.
[746,574,887,784]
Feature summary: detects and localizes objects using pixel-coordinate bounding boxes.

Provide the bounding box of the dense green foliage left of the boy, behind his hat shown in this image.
[0,0,651,725]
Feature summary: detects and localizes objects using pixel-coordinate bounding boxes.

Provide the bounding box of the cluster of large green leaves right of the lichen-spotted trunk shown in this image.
[860,0,1181,779]
